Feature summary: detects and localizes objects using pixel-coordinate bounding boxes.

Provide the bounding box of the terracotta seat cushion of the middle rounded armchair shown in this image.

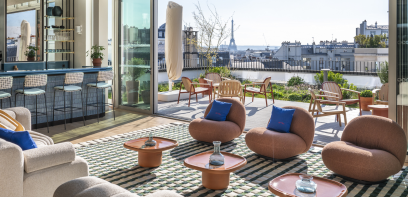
[245,127,307,159]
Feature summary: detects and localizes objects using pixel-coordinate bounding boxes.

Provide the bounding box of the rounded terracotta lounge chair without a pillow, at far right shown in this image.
[322,115,407,182]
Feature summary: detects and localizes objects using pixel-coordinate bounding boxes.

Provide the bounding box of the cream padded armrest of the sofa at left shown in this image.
[23,142,75,173]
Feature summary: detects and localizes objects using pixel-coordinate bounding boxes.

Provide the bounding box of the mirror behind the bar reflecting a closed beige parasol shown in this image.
[5,0,42,62]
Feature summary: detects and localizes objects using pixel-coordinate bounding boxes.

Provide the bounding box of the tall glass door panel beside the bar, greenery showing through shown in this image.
[117,0,153,111]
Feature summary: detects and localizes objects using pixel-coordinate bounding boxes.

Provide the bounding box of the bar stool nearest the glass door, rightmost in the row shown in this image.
[85,71,115,123]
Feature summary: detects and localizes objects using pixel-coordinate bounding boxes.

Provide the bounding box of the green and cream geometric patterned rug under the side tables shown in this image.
[75,124,408,197]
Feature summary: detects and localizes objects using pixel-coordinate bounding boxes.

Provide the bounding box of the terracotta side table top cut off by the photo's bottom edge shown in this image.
[268,173,348,197]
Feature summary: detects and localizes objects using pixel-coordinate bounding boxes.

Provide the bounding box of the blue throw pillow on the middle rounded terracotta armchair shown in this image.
[267,106,295,133]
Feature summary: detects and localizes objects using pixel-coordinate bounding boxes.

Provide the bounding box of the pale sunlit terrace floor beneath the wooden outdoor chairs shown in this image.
[159,96,371,145]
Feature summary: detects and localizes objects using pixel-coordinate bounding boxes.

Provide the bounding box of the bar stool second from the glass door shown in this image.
[52,72,85,130]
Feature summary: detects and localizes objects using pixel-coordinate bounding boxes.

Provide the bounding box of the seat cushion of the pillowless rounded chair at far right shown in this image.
[322,141,402,182]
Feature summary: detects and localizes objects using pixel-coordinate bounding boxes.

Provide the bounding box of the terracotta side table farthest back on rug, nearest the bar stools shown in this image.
[123,137,178,168]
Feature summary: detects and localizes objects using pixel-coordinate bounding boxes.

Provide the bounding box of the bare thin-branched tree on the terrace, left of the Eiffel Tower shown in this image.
[187,2,236,67]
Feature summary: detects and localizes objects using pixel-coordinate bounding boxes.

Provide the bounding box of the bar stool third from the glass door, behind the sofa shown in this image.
[14,75,50,133]
